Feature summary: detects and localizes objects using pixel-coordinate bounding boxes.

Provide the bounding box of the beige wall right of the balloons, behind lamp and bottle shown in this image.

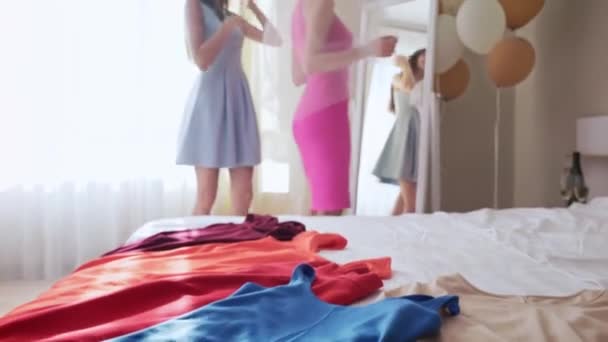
[514,0,608,206]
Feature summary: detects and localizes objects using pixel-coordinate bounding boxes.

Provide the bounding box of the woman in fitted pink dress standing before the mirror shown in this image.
[292,0,397,215]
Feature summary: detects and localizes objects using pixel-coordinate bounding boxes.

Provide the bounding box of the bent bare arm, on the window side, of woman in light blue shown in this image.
[186,0,243,71]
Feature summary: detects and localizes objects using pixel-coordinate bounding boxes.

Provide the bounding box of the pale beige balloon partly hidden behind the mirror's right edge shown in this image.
[435,14,464,74]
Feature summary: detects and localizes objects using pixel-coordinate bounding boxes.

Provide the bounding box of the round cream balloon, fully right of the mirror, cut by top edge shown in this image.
[456,0,507,55]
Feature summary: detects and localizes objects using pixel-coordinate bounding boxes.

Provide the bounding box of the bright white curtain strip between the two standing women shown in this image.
[246,0,310,214]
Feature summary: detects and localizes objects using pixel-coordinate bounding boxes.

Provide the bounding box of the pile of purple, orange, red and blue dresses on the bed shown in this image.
[0,215,460,341]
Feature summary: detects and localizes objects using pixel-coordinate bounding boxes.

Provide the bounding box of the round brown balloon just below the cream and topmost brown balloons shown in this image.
[486,37,536,88]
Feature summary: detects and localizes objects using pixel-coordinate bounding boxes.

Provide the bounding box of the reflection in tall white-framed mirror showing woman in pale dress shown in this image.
[357,0,430,215]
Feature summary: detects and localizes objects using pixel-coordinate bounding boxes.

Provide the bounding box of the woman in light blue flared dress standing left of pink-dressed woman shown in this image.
[177,0,281,215]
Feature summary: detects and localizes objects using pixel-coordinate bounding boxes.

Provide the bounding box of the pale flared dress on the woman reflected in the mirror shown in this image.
[373,89,420,184]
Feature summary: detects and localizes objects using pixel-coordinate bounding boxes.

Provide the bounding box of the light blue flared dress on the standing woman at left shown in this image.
[177,4,261,168]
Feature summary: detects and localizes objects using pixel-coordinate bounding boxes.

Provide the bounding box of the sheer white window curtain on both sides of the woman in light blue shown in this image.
[0,0,304,279]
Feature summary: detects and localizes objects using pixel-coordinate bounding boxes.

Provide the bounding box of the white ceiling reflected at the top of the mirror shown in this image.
[383,0,431,30]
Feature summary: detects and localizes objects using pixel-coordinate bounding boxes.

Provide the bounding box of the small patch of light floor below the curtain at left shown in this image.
[0,281,53,317]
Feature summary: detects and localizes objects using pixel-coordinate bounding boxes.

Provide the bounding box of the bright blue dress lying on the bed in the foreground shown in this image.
[113,265,460,342]
